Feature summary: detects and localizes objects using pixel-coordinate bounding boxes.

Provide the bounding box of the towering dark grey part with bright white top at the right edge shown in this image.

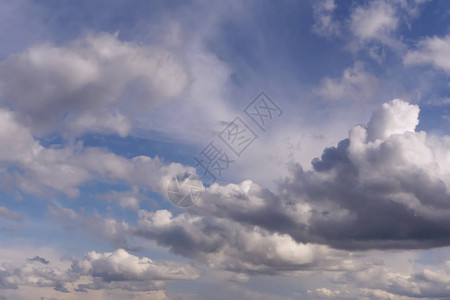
[283,100,450,249]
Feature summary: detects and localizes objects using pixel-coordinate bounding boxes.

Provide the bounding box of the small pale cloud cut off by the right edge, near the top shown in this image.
[403,35,450,74]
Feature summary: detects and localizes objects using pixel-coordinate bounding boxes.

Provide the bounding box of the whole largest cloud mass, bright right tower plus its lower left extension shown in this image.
[135,99,450,274]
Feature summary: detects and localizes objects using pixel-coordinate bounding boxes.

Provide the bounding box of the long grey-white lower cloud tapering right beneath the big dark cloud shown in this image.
[136,206,357,274]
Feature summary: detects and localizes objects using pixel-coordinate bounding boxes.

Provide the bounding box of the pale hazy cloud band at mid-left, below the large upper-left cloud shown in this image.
[0,109,189,197]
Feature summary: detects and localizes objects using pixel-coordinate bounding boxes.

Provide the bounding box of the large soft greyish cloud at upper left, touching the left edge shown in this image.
[0,33,188,136]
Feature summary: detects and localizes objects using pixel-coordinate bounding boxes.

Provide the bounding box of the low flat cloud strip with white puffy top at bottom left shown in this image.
[0,249,198,293]
